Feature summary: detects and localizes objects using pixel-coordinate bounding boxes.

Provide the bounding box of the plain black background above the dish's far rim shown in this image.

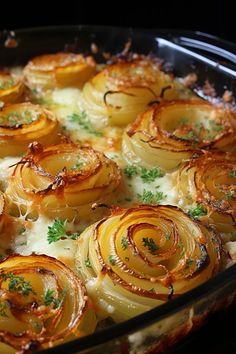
[0,0,236,42]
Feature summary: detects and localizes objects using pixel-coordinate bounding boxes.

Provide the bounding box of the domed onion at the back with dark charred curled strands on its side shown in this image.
[80,58,176,126]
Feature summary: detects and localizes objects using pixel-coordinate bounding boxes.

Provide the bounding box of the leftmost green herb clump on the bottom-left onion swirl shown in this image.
[0,273,35,296]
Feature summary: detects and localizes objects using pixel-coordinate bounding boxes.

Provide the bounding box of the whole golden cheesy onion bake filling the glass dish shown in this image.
[0,53,236,354]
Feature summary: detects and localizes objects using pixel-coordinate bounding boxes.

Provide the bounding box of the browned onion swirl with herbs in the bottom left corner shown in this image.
[0,255,96,353]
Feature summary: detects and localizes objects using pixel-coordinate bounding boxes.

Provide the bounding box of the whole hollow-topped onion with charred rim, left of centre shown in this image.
[6,142,121,220]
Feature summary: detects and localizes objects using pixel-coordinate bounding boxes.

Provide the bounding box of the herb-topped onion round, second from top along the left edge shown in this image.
[0,103,59,157]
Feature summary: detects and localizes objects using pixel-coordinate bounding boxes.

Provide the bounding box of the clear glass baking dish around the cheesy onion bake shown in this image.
[0,26,236,354]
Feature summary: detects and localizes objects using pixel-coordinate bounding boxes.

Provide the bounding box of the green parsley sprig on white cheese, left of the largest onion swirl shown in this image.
[47,219,80,244]
